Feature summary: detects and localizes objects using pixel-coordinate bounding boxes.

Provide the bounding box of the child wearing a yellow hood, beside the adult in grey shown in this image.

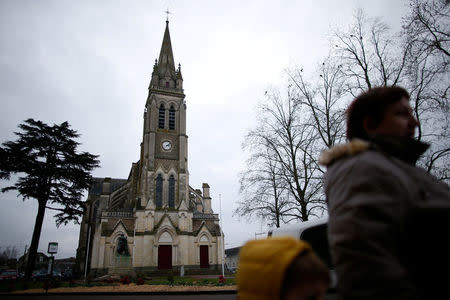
[236,236,330,300]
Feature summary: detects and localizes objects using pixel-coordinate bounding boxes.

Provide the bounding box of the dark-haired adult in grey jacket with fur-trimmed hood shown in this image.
[320,87,450,299]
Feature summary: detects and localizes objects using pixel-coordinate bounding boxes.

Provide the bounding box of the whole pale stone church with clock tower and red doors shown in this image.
[77,21,224,276]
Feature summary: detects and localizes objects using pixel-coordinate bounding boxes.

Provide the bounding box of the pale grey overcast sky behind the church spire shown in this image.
[0,0,407,257]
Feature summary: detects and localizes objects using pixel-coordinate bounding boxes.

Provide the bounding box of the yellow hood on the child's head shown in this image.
[236,236,311,300]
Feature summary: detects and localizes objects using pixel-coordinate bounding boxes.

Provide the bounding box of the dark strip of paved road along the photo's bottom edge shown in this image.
[2,294,236,300]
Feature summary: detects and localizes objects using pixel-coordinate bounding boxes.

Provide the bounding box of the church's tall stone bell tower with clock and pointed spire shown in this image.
[138,20,189,210]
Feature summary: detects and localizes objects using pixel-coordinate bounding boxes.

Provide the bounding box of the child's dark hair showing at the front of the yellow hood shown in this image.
[280,251,330,299]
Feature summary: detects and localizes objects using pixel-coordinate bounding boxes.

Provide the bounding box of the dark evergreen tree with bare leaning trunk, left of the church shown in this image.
[0,119,99,278]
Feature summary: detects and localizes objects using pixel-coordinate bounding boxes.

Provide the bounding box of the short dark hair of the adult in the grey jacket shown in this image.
[347,86,409,140]
